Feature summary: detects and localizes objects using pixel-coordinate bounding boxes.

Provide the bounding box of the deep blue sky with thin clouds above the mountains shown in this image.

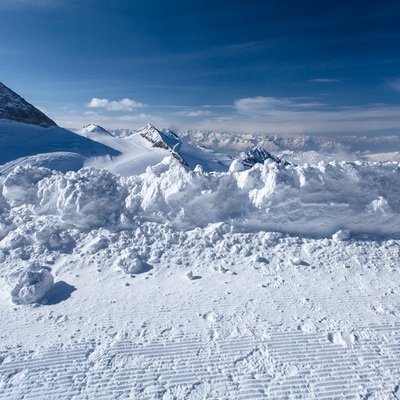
[0,0,400,135]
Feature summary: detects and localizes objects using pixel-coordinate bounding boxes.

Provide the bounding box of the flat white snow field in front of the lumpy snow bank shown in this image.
[0,227,400,399]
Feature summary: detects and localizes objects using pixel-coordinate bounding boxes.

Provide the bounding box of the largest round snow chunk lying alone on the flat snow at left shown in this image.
[11,268,54,304]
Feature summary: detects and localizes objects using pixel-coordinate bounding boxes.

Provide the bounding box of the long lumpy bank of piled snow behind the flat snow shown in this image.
[0,157,400,239]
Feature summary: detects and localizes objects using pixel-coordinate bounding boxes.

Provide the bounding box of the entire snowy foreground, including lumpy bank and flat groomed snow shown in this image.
[0,157,400,399]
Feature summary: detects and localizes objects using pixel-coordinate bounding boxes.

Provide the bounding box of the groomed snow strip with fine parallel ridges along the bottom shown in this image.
[0,323,400,399]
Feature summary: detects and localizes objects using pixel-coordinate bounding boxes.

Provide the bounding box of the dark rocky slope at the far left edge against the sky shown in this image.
[0,82,57,128]
